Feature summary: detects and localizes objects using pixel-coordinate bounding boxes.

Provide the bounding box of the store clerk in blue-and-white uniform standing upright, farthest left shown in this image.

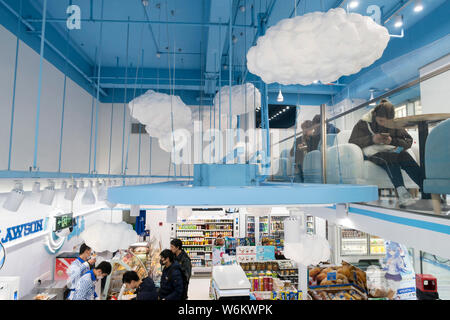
[64,243,96,300]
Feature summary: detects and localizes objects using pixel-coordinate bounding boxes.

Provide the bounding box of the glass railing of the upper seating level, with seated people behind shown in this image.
[271,57,450,216]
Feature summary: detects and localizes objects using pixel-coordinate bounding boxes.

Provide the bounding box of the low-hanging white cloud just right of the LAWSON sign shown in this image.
[80,221,137,252]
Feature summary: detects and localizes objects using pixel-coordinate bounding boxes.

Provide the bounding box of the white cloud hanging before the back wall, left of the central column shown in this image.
[128,90,193,152]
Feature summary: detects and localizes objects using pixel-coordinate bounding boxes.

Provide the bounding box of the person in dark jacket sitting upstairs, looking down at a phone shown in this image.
[349,99,429,207]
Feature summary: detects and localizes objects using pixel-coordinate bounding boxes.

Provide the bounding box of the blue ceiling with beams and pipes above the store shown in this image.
[0,0,450,104]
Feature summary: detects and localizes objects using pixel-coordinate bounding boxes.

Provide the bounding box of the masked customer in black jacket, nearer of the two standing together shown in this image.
[158,249,184,300]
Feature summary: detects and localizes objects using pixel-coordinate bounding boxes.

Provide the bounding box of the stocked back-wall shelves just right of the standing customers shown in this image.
[176,219,234,273]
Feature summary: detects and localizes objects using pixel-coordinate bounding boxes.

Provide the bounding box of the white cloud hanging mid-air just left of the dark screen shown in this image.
[214,83,261,116]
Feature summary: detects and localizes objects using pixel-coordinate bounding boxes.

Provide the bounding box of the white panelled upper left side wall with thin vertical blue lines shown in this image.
[0,26,91,172]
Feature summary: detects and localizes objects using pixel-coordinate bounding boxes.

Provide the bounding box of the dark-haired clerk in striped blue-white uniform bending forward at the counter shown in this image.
[72,261,112,300]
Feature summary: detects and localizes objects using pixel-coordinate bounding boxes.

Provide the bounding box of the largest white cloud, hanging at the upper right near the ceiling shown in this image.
[247,8,390,85]
